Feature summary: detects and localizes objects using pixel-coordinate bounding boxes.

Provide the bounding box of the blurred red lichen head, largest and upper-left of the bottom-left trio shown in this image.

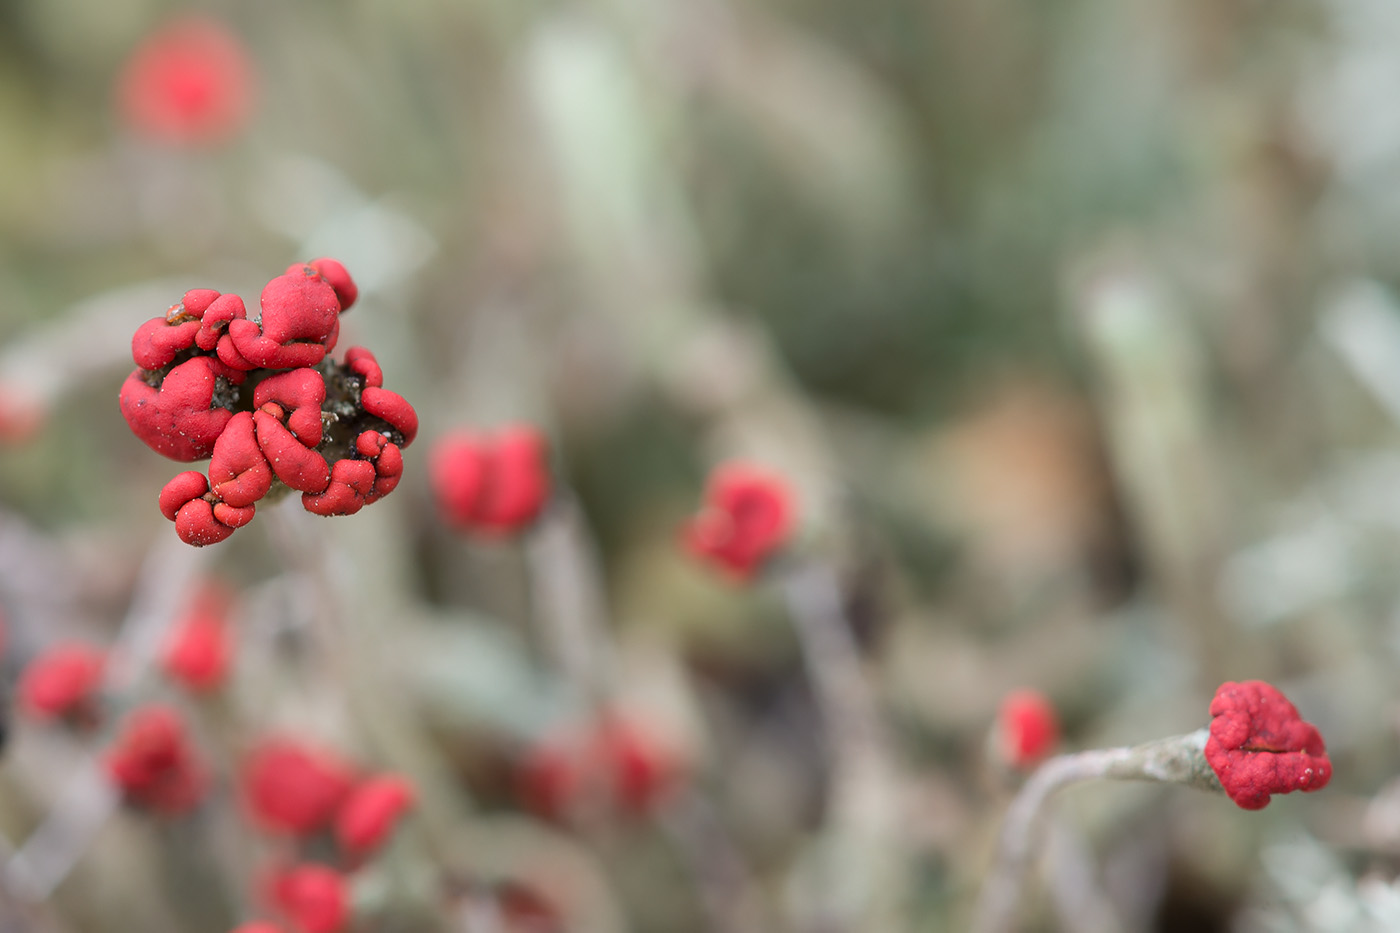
[241,738,354,836]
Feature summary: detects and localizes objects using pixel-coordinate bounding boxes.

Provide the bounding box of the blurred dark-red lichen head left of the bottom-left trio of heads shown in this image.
[106,706,207,815]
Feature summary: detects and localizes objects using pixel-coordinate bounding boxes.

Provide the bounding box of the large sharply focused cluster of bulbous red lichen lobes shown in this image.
[120,259,419,546]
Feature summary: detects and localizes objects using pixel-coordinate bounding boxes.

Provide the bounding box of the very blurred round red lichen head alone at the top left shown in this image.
[116,15,253,146]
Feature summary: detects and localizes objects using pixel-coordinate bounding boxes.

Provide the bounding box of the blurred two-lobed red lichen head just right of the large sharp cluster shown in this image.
[428,424,550,537]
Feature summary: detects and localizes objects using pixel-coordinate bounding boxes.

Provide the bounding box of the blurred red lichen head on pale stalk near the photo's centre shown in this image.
[682,462,792,580]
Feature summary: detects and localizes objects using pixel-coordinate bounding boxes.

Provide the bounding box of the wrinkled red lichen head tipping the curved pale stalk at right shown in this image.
[1205,681,1331,810]
